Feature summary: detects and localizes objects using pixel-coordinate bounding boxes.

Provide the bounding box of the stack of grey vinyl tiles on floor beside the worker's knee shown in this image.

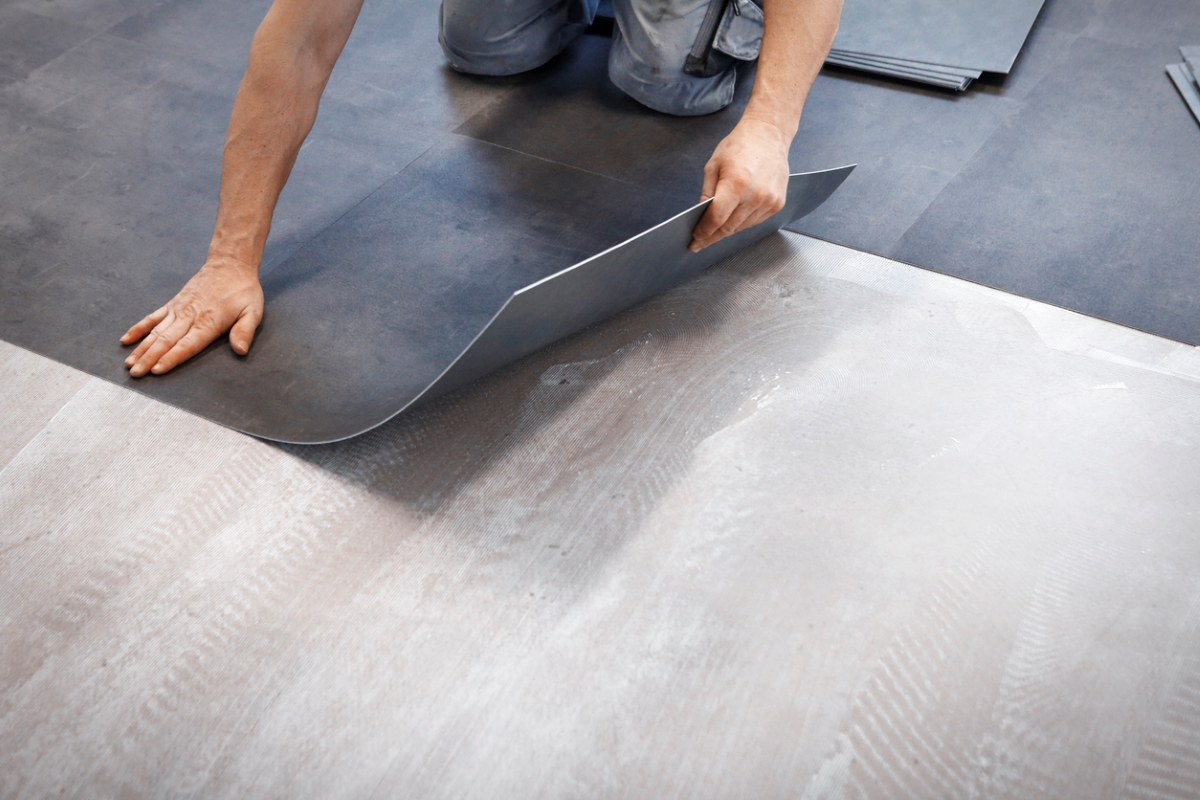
[826,0,1044,91]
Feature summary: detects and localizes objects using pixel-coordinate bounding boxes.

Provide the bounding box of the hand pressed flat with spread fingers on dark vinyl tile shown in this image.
[121,258,263,378]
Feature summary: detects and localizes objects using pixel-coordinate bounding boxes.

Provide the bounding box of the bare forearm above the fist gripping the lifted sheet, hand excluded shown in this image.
[742,0,841,142]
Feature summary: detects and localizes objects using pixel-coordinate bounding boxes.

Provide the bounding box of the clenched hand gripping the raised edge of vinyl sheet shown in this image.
[689,118,791,253]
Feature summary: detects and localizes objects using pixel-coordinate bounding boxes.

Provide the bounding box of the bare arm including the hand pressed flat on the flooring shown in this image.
[121,0,362,378]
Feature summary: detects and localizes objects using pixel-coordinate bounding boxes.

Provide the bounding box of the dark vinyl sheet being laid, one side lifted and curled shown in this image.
[114,138,853,444]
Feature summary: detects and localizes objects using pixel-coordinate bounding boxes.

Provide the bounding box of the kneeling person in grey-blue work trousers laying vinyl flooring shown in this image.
[121,0,841,378]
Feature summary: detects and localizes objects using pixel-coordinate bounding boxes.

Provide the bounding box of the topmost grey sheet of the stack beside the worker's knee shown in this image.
[834,0,1044,73]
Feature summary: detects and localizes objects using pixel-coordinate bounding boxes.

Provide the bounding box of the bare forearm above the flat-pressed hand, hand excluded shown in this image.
[209,0,358,270]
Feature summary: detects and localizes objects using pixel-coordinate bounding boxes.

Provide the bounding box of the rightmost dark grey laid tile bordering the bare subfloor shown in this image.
[889,38,1200,344]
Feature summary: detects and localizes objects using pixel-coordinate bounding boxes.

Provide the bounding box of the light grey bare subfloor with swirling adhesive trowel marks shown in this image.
[7,234,1200,799]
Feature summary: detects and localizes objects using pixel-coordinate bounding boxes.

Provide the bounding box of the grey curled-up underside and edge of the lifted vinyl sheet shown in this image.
[279,164,854,445]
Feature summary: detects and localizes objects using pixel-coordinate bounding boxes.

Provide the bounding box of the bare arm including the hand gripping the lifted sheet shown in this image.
[691,0,841,251]
